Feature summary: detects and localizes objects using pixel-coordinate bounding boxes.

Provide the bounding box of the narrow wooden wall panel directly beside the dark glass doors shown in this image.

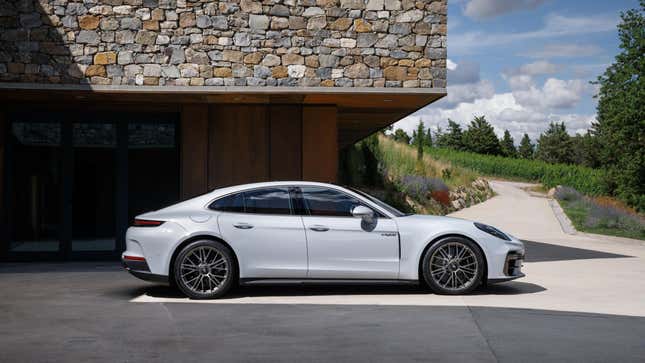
[180,104,208,199]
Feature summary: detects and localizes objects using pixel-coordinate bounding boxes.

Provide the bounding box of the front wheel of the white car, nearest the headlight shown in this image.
[421,237,485,295]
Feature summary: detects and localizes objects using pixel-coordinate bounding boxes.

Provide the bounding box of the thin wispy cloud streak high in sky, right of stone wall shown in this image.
[448,14,618,54]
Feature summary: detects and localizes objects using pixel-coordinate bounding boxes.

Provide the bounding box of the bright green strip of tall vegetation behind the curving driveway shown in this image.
[426,148,606,196]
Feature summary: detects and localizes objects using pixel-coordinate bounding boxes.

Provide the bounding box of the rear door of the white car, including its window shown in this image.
[213,187,307,278]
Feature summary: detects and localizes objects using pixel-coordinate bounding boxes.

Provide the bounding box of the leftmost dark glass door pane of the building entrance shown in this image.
[5,119,63,257]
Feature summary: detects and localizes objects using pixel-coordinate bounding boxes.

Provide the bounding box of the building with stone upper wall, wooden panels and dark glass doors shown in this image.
[0,0,446,260]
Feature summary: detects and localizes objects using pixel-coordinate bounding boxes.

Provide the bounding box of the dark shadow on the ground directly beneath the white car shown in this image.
[130,281,546,300]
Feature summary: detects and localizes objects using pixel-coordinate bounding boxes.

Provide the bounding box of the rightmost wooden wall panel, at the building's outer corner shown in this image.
[302,106,338,183]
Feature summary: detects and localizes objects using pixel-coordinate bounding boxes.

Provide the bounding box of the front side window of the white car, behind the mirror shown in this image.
[301,187,364,217]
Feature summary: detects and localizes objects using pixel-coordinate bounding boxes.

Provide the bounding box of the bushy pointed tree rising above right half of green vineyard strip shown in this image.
[536,122,573,164]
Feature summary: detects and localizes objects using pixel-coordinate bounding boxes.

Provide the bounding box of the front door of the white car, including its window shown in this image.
[300,186,399,279]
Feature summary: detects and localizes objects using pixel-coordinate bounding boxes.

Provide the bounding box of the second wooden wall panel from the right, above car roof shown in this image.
[269,105,302,181]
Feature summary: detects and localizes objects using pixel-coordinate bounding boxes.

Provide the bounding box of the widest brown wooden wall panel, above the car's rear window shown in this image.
[208,104,270,188]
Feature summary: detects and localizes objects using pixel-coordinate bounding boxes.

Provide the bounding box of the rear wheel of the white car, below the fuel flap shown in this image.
[174,240,238,299]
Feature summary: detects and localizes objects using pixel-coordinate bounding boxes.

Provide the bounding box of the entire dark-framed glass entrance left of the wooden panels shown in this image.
[0,112,179,261]
